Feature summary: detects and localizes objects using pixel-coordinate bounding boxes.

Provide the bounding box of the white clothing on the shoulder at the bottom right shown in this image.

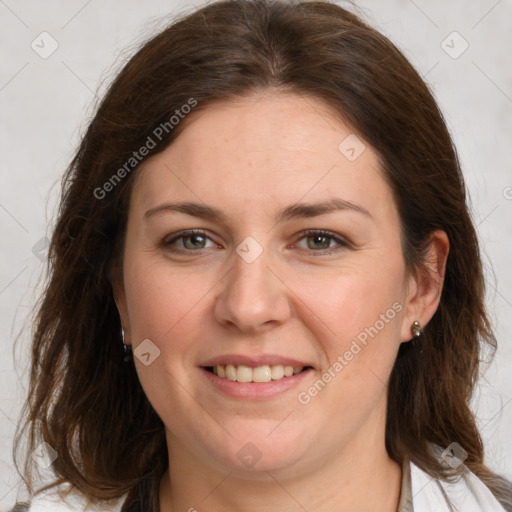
[410,446,506,512]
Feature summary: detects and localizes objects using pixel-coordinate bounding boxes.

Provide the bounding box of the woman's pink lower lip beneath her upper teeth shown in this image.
[200,368,313,400]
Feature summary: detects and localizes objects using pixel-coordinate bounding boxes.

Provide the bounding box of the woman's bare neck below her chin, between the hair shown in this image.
[160,424,402,512]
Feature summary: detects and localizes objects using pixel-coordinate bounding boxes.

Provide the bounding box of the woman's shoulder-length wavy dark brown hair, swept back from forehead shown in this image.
[15,0,512,510]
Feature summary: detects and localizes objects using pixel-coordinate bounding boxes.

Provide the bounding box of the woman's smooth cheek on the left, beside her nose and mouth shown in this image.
[121,255,215,410]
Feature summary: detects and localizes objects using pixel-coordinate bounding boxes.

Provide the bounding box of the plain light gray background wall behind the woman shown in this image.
[0,0,512,510]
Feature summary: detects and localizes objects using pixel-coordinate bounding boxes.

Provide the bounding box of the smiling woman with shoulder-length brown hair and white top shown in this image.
[11,0,512,512]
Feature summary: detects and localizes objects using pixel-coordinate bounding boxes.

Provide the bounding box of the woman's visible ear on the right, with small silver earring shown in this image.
[401,230,450,341]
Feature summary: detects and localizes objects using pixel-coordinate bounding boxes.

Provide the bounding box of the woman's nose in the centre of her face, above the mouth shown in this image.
[214,242,291,334]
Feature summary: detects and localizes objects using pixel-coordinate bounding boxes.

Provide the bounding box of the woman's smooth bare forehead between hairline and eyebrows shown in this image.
[133,93,393,225]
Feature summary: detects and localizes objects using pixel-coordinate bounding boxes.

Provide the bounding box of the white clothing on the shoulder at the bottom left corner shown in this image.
[10,489,124,512]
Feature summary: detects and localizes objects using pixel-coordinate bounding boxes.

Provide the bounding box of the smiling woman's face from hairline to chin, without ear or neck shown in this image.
[115,93,428,478]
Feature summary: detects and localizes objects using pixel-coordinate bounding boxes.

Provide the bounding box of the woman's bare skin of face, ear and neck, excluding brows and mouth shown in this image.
[114,92,448,512]
